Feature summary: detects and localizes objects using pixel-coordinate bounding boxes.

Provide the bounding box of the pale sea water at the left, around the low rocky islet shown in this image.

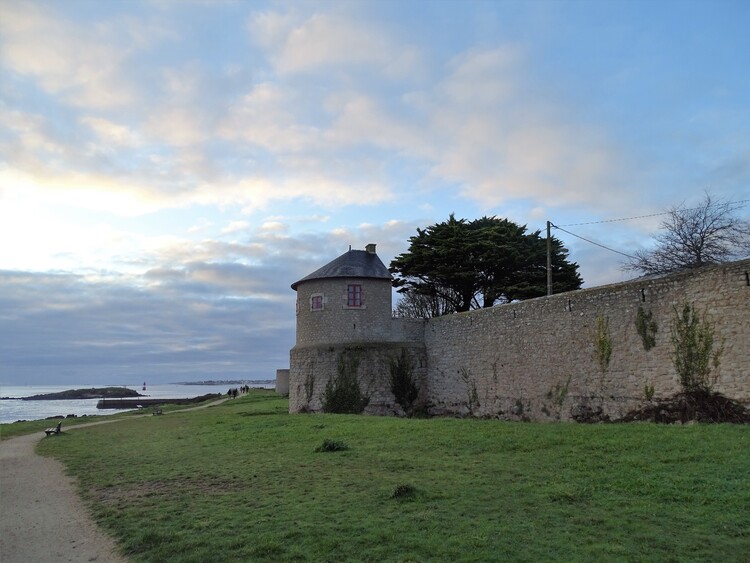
[0,381,275,424]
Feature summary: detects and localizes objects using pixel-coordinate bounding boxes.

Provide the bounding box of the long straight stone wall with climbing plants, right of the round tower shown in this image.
[425,260,750,420]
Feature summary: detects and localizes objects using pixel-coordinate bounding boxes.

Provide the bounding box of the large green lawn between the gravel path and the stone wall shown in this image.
[39,391,750,562]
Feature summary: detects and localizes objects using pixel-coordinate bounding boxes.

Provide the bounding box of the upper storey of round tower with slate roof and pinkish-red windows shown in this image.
[292,244,392,348]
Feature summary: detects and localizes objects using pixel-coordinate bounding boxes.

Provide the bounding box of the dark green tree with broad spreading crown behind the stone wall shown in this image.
[389,214,582,316]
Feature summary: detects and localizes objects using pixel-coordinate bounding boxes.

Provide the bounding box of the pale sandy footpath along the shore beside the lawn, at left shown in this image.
[0,399,226,563]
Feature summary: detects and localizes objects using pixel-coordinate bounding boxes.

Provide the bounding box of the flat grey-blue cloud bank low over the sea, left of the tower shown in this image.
[0,272,294,384]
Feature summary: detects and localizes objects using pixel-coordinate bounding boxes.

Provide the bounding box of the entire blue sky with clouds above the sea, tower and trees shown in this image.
[0,0,750,393]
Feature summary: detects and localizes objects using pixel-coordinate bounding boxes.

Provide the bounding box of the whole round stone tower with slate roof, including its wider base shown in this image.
[289,244,424,414]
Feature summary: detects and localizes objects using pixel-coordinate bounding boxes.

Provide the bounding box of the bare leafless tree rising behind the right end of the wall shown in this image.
[624,192,750,274]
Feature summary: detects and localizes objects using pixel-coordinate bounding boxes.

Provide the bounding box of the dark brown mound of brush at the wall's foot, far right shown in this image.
[617,389,750,424]
